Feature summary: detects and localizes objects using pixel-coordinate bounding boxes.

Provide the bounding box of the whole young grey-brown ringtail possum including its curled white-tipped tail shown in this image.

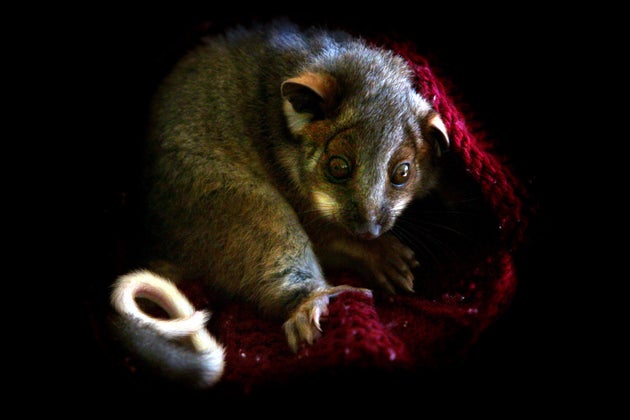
[111,21,449,387]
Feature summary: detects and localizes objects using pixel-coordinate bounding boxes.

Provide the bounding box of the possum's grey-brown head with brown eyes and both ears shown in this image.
[281,52,449,239]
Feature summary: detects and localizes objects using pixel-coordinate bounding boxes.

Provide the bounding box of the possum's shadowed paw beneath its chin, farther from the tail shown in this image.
[364,235,420,294]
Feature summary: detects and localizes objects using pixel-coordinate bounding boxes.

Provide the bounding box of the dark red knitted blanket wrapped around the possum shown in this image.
[94,34,526,394]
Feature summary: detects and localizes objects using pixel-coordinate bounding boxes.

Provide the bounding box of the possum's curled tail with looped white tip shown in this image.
[111,270,225,388]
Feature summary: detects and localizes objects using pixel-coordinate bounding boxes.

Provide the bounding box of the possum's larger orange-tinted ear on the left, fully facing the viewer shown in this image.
[280,72,337,133]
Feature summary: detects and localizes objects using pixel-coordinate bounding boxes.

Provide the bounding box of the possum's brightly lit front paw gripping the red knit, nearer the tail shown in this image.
[282,285,372,352]
